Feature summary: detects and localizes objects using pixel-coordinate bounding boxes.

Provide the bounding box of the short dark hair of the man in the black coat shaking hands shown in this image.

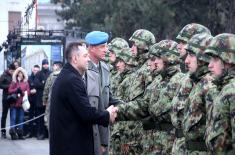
[65,41,86,62]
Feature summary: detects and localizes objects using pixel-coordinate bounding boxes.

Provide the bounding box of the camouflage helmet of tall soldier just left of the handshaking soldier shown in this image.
[129,29,156,50]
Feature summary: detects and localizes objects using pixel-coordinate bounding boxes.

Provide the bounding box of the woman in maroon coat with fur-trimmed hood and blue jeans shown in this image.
[8,67,30,140]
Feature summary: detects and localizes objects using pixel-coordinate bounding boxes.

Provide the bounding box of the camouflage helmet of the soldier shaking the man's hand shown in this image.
[149,40,180,64]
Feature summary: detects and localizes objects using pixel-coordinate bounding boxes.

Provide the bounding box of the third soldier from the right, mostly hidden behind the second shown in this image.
[171,23,211,154]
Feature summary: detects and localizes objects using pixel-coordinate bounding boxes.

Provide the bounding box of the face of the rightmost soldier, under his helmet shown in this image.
[208,57,224,77]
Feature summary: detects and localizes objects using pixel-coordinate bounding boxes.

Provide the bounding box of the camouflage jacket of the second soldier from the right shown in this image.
[183,69,212,142]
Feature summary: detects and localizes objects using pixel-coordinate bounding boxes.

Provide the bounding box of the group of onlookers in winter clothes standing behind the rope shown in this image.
[0,59,63,140]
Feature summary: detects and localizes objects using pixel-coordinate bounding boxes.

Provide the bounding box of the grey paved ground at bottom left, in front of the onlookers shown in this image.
[0,90,49,155]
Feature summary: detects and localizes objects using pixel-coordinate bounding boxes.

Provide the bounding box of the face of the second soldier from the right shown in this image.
[185,53,198,73]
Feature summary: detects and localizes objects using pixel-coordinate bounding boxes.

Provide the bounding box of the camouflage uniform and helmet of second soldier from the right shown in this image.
[183,33,216,155]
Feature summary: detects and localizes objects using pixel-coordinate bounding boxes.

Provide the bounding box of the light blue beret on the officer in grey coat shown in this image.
[85,31,109,45]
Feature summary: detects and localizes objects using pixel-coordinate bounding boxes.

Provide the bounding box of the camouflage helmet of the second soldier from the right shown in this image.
[185,33,213,62]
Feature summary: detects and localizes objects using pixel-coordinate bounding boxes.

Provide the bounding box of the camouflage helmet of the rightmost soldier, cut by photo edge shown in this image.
[205,33,235,64]
